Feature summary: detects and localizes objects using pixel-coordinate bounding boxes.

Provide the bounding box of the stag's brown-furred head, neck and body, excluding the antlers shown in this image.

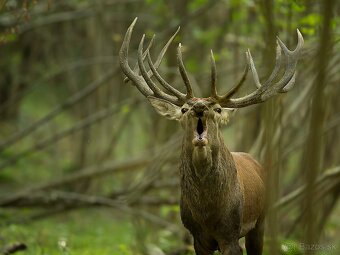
[149,98,265,255]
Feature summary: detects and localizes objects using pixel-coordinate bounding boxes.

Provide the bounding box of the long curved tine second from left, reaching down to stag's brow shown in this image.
[138,34,180,104]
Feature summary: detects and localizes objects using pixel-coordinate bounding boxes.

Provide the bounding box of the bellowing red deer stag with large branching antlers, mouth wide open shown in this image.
[119,19,303,255]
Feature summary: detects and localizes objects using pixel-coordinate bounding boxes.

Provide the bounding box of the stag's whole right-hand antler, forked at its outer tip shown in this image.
[211,29,303,108]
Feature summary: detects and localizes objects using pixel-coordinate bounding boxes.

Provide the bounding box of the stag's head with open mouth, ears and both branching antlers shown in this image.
[119,18,303,149]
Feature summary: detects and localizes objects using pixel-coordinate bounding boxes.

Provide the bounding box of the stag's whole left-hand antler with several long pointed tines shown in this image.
[119,18,193,106]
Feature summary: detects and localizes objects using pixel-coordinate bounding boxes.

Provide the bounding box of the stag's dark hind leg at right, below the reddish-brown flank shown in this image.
[246,219,264,255]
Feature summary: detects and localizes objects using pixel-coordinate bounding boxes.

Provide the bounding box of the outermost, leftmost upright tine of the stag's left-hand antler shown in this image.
[119,18,153,97]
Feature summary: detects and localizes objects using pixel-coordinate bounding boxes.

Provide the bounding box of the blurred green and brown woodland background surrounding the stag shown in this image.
[0,0,340,255]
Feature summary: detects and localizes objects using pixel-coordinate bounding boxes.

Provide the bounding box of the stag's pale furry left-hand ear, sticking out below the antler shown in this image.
[147,96,182,120]
